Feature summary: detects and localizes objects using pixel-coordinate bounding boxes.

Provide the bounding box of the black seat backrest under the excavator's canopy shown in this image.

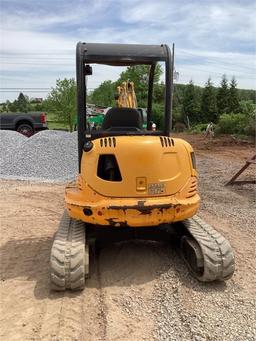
[102,108,142,130]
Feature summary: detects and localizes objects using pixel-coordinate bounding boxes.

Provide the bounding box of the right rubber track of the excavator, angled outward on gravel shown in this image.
[183,216,235,282]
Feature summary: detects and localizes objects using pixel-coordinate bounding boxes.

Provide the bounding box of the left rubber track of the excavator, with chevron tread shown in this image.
[50,210,89,291]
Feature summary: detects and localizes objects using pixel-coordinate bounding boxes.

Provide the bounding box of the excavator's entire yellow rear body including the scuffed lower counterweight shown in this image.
[65,136,200,226]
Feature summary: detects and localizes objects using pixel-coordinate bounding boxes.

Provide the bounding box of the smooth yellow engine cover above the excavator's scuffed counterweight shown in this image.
[81,136,196,198]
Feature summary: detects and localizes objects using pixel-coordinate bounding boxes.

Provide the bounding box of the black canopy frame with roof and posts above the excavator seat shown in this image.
[76,42,173,170]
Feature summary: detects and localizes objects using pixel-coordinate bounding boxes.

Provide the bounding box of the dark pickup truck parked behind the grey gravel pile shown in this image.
[0,112,48,137]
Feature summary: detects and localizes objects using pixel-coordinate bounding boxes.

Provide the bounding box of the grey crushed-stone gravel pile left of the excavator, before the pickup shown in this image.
[0,130,78,181]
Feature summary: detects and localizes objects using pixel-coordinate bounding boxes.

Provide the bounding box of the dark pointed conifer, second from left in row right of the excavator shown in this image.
[201,78,218,123]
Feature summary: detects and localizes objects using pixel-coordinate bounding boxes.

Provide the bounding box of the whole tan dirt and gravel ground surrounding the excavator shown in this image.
[0,134,256,341]
